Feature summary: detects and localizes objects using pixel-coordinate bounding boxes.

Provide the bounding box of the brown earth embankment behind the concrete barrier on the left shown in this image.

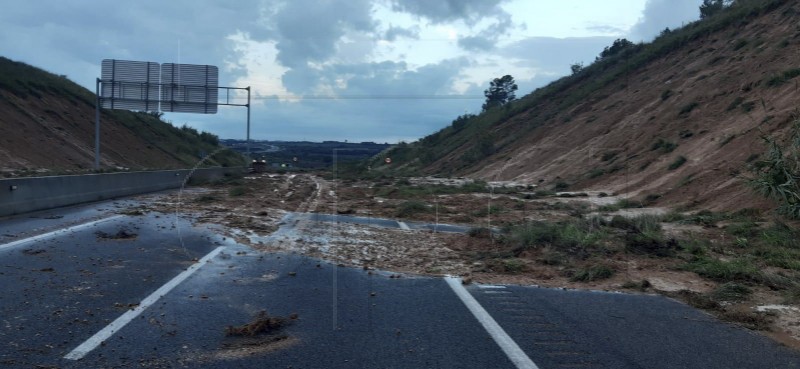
[0,57,241,175]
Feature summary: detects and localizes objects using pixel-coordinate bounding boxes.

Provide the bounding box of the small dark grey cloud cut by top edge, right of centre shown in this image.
[391,0,504,24]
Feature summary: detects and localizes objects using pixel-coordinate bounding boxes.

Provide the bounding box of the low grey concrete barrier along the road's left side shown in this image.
[0,167,245,216]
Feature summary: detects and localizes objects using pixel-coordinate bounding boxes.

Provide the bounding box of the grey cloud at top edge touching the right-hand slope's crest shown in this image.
[629,0,701,42]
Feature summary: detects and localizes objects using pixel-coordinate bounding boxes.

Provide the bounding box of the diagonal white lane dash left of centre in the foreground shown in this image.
[64,246,225,360]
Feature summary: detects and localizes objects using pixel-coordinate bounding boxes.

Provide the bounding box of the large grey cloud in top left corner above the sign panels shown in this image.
[0,0,266,85]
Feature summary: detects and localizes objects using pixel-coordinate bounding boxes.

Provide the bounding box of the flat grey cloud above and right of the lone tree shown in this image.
[499,37,616,75]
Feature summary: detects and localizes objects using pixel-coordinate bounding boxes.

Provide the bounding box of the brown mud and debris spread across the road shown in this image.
[133,174,800,350]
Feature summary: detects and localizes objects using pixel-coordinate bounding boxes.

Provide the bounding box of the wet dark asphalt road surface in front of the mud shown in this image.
[0,197,800,368]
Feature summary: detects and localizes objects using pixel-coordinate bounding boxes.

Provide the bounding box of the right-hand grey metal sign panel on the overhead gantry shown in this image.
[161,63,219,114]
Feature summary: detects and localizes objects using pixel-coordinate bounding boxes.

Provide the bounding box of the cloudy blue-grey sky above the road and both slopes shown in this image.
[0,0,701,143]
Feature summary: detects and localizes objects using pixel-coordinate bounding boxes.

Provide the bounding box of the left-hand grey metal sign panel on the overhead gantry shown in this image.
[100,59,160,111]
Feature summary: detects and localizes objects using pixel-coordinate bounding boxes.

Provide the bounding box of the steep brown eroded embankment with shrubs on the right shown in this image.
[380,0,800,210]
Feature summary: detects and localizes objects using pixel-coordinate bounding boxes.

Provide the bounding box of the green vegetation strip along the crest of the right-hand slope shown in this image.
[371,0,796,175]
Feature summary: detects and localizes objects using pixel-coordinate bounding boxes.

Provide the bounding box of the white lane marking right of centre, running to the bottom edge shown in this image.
[444,277,539,369]
